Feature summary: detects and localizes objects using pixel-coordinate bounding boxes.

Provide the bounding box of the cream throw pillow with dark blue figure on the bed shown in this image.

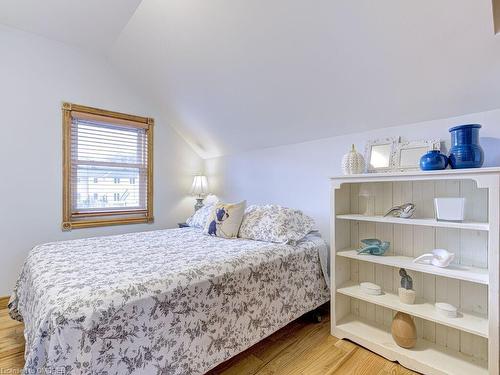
[203,201,247,238]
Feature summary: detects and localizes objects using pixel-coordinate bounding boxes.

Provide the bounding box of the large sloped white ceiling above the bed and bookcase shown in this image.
[0,0,500,157]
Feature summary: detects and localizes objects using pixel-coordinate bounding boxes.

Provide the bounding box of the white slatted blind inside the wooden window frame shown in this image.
[70,114,149,216]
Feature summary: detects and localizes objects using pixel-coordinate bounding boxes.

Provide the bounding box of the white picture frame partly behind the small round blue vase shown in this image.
[393,139,441,171]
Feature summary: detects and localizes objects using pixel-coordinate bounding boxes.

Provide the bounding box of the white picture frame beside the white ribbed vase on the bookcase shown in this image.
[365,137,399,173]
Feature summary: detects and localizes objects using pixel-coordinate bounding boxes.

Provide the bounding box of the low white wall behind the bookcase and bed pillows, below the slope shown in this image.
[206,109,500,240]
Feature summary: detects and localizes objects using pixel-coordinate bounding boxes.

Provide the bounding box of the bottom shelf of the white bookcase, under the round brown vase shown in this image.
[333,315,488,375]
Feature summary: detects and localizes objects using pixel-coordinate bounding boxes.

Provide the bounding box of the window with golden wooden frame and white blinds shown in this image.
[62,103,154,230]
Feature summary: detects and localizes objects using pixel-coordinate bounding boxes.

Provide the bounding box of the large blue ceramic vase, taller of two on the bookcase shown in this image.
[449,124,484,169]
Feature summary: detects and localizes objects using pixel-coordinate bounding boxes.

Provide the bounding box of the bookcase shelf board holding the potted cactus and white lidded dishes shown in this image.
[337,281,488,338]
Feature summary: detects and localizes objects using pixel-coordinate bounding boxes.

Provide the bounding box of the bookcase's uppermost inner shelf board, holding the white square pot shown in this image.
[337,214,490,231]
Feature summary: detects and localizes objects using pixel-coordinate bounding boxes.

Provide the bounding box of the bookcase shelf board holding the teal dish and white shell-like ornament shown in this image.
[337,249,489,285]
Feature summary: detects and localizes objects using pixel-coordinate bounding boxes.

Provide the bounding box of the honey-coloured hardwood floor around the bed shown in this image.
[0,309,415,375]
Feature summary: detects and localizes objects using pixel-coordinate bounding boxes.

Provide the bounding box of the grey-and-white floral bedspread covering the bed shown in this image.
[9,228,329,375]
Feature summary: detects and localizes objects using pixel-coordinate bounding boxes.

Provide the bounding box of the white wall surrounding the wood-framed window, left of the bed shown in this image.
[0,26,202,296]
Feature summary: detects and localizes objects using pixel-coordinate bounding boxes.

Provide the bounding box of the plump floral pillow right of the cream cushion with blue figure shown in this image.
[238,205,314,244]
